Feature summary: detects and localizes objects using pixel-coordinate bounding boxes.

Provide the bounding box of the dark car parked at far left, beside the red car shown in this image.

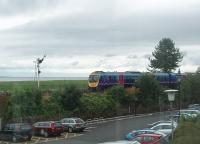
[0,123,32,142]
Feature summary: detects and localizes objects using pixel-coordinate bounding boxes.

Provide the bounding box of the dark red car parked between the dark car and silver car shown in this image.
[33,121,64,137]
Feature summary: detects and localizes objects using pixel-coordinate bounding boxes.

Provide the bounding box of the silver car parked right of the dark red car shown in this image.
[61,118,86,133]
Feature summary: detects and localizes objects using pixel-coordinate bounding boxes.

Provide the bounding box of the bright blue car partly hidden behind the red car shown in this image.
[125,129,166,140]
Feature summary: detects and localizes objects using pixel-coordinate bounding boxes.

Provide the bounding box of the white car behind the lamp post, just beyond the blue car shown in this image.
[150,123,176,135]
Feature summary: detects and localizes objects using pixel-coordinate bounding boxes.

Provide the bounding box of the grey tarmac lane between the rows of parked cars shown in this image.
[46,112,169,144]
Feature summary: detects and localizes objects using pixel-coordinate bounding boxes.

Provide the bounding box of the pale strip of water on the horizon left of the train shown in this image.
[0,76,88,82]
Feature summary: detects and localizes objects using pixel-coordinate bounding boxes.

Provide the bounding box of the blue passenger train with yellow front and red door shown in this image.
[88,71,177,90]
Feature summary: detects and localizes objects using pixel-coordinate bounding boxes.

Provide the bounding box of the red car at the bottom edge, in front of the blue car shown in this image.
[132,134,162,144]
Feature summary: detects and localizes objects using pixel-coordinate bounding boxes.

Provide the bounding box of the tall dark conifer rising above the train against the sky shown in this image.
[149,38,183,72]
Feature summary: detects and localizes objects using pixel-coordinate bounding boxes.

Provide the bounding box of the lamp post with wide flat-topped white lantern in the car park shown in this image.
[164,89,178,141]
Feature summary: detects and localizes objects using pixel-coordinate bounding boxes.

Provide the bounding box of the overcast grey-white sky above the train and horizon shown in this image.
[0,0,200,77]
